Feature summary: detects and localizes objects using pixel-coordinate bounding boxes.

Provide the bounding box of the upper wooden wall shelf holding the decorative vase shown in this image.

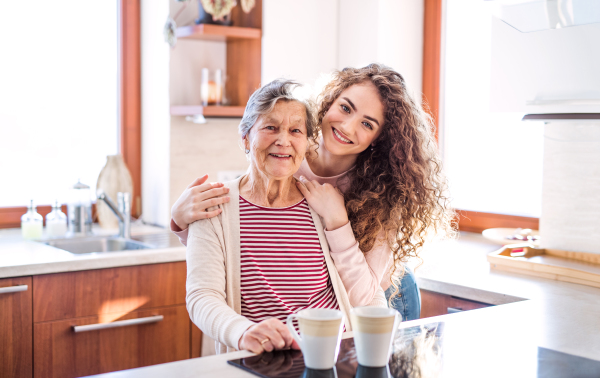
[176,24,262,41]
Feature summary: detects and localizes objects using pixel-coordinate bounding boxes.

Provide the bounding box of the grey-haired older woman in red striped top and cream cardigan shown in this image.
[186,80,358,353]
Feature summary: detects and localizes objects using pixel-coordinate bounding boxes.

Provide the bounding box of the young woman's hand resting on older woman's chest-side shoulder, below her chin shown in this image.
[296,176,348,231]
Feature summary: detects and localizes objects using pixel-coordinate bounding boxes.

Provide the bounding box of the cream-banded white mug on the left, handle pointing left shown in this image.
[287,308,344,370]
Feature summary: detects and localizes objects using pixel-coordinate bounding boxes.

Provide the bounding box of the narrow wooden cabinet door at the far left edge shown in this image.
[0,277,33,378]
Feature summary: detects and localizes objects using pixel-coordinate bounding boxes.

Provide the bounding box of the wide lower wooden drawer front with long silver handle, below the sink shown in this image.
[34,305,191,378]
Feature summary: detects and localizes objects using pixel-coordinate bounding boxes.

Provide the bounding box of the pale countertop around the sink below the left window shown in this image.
[0,225,185,278]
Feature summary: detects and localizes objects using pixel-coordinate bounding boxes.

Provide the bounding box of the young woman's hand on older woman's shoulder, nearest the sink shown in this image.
[171,175,229,230]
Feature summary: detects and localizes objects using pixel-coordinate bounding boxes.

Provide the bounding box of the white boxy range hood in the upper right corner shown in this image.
[490,17,600,113]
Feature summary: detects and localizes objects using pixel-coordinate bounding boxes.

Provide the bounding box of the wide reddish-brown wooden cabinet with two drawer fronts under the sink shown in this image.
[32,262,202,378]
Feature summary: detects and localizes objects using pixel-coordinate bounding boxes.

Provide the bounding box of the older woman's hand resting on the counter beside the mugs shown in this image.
[238,318,300,354]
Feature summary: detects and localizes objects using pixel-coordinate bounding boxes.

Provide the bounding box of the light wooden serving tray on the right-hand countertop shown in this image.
[487,244,600,287]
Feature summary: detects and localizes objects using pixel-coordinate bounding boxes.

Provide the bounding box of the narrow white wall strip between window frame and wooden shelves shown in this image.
[141,1,170,226]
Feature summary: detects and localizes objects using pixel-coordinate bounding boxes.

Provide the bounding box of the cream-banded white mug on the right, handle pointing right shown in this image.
[350,307,402,367]
